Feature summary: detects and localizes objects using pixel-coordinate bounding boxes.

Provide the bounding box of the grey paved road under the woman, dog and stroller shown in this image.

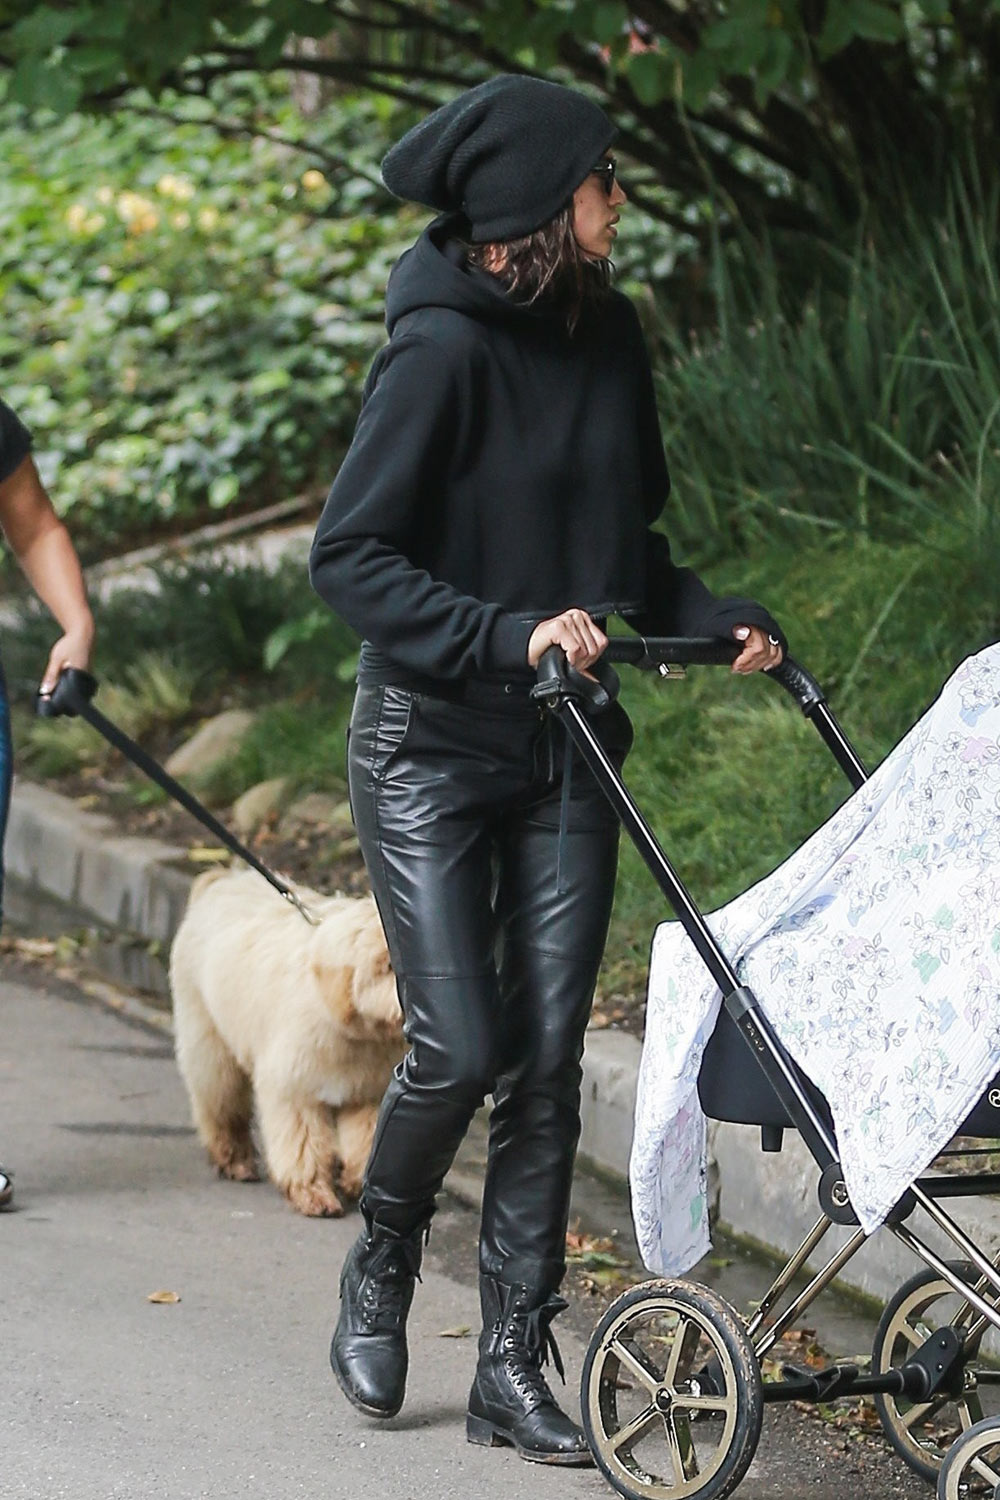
[0,969,930,1500]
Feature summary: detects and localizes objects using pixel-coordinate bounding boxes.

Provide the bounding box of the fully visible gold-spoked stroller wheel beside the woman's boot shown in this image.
[580,1281,763,1500]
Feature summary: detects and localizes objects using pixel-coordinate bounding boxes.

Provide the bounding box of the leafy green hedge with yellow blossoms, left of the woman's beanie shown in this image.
[0,90,412,555]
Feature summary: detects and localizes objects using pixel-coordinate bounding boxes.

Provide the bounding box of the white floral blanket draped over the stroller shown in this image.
[630,644,1000,1274]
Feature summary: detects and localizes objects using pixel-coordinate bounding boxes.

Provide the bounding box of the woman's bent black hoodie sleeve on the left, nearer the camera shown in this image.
[309,338,532,678]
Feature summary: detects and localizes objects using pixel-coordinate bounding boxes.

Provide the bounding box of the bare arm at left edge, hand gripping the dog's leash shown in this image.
[0,458,94,693]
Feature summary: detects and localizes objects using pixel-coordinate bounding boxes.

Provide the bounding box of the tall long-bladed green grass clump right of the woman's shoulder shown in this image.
[657,170,1000,561]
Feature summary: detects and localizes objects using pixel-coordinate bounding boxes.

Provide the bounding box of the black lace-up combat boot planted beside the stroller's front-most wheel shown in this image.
[465,1277,594,1464]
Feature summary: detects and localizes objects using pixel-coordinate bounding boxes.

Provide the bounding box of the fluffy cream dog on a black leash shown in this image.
[169,870,403,1215]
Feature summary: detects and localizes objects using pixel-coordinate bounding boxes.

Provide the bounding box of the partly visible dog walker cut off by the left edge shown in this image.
[0,401,94,1208]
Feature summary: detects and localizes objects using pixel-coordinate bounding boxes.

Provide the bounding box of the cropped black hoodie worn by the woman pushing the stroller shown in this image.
[310,216,777,681]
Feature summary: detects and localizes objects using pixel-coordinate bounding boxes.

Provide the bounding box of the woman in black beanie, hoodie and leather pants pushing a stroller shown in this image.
[310,77,781,1464]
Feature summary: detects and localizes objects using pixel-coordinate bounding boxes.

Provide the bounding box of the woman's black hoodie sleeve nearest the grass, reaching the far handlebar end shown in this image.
[628,309,787,651]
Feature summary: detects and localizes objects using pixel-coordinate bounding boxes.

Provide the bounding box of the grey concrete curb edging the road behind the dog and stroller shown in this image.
[6,780,1000,1301]
